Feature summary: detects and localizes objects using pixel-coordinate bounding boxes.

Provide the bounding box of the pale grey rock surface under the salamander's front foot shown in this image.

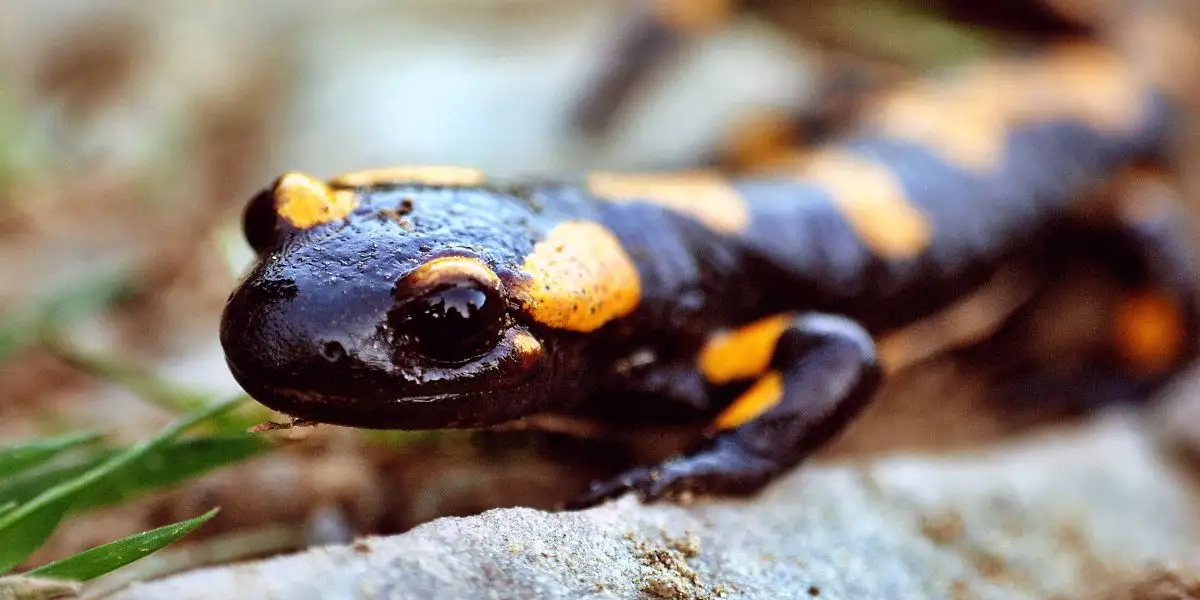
[105,416,1200,600]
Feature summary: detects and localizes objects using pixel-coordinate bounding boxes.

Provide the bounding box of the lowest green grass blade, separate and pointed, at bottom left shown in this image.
[29,509,220,581]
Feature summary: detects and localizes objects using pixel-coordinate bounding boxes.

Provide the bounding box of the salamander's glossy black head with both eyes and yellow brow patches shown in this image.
[221,173,614,430]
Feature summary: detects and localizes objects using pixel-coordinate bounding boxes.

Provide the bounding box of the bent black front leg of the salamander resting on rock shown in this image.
[569,314,881,508]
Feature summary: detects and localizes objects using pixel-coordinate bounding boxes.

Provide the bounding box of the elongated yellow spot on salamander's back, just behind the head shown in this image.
[588,172,750,234]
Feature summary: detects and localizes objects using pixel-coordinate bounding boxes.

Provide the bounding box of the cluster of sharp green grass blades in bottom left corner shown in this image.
[0,396,266,598]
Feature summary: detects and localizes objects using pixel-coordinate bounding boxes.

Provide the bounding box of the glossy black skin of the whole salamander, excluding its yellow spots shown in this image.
[221,65,1200,508]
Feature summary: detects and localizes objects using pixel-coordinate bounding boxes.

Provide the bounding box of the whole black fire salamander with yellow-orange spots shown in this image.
[221,38,1200,506]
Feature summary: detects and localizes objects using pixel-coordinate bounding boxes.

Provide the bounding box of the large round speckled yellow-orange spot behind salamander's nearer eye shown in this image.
[516,221,642,331]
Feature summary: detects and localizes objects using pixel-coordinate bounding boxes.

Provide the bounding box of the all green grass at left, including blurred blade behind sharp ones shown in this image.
[0,283,270,599]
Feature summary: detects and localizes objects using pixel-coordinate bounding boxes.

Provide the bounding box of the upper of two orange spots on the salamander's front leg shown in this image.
[697,313,792,385]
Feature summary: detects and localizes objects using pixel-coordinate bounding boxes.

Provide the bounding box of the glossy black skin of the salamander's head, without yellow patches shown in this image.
[221,185,597,430]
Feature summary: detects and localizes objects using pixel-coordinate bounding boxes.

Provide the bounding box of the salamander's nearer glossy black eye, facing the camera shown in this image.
[404,280,504,362]
